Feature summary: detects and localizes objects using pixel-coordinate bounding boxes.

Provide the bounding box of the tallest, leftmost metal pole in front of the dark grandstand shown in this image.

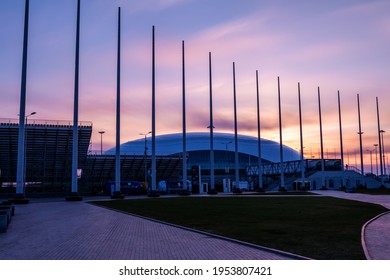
[16,0,29,199]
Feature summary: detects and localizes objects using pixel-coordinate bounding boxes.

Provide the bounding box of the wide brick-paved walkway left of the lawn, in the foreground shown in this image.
[0,199,300,260]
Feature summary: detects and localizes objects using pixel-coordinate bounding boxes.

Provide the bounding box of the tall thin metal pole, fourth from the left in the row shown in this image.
[151,26,156,191]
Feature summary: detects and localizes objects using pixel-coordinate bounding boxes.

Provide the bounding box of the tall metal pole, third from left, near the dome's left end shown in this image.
[115,7,121,192]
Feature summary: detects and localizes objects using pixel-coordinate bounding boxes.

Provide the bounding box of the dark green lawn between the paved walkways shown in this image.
[90,196,386,260]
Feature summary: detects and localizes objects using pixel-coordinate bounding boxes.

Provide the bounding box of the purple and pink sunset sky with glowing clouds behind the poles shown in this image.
[0,0,390,171]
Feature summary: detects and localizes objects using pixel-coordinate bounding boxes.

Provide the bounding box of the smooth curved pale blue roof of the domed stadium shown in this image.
[106,132,300,162]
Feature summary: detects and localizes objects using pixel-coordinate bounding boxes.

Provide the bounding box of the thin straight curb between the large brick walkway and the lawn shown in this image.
[89,201,310,260]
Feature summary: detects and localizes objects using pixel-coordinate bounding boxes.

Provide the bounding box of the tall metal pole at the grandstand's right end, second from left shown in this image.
[72,0,80,193]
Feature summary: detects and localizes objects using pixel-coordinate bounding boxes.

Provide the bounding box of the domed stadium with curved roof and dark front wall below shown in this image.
[105,132,300,190]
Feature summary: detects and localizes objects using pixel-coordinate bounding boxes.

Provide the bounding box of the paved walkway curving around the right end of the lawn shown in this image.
[313,190,390,260]
